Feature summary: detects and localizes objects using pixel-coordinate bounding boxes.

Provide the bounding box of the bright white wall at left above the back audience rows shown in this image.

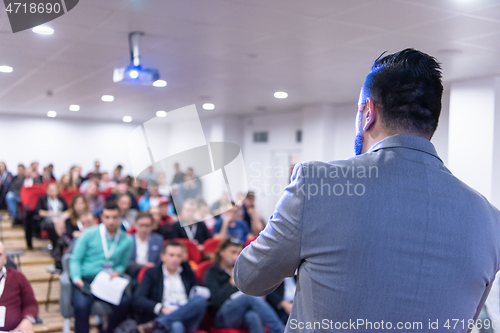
[0,116,137,177]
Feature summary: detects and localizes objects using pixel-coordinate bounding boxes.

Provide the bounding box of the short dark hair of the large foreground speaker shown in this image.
[364,49,443,136]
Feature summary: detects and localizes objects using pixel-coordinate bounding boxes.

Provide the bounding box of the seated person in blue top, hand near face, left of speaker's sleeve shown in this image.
[214,203,253,243]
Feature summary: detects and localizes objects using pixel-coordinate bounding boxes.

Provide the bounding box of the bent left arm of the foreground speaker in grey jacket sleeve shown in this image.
[234,163,307,296]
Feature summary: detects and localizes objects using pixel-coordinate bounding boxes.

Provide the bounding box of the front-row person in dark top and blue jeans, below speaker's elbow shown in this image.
[203,237,285,333]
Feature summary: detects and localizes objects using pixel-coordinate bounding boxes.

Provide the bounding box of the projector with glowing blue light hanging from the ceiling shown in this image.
[113,31,160,85]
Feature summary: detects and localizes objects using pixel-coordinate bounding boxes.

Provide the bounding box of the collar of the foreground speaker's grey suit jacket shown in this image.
[367,134,443,163]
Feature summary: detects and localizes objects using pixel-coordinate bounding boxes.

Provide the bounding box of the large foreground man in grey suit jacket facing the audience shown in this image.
[235,49,500,332]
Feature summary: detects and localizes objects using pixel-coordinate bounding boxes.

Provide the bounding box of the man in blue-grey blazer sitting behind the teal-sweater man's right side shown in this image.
[125,213,163,278]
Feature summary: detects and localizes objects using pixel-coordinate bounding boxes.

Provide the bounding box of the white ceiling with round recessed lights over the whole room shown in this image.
[0,0,500,122]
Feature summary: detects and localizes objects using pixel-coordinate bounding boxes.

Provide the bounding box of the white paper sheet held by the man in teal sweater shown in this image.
[90,271,129,305]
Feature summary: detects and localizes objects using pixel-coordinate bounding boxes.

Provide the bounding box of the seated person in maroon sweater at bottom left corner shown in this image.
[0,242,38,333]
